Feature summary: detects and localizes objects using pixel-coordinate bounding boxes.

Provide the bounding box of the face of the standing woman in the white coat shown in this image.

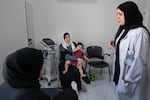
[117,9,125,26]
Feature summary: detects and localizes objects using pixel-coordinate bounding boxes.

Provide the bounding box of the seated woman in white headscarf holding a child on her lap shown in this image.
[59,33,88,90]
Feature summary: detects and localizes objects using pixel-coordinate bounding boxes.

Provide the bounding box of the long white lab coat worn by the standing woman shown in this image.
[114,28,150,100]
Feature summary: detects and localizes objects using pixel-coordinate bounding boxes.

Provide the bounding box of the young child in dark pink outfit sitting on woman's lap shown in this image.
[63,42,90,77]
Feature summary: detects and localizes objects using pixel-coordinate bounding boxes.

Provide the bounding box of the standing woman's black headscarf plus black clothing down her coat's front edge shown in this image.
[113,1,144,85]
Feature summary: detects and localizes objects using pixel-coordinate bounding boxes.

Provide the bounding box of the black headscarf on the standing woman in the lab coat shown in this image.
[115,1,143,41]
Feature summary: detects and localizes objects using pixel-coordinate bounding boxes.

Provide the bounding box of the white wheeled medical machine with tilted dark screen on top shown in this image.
[41,38,58,86]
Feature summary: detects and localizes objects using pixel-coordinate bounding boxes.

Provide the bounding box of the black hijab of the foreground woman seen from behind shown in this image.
[3,47,43,88]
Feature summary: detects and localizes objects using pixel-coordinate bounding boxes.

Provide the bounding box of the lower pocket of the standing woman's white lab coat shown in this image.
[117,80,132,94]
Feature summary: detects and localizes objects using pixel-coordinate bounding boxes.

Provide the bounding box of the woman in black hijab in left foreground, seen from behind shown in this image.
[0,47,51,100]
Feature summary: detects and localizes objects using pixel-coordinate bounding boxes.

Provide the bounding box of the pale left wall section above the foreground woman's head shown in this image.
[0,0,27,84]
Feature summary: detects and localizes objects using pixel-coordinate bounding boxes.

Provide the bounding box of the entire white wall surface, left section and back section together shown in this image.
[0,0,150,83]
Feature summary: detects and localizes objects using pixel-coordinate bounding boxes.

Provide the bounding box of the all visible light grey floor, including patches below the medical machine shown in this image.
[40,68,116,100]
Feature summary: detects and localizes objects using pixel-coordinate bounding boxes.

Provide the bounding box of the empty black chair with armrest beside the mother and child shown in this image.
[87,46,111,81]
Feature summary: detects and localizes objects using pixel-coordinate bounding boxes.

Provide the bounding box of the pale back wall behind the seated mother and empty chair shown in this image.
[30,0,146,52]
